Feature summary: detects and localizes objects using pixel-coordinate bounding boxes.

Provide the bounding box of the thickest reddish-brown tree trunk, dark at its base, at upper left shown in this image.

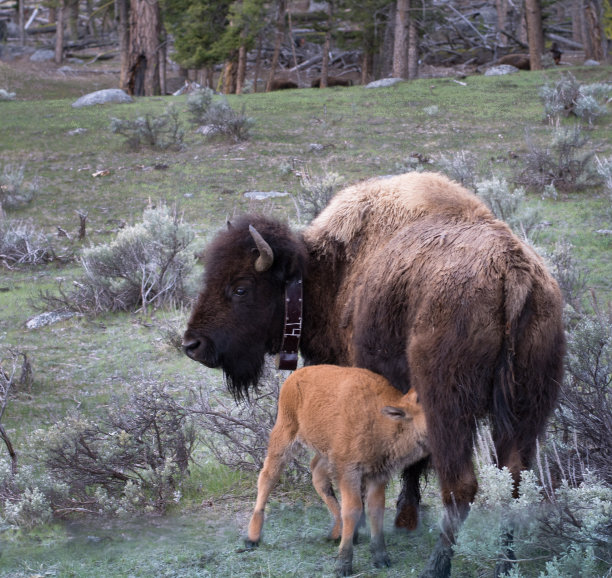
[127,0,161,96]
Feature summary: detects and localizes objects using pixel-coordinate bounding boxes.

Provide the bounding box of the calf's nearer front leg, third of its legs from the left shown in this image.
[336,473,363,576]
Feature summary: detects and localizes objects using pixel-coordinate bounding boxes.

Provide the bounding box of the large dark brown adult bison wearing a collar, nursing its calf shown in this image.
[184,173,565,576]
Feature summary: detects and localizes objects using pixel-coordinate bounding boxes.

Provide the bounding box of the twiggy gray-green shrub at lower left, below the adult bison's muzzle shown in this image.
[38,380,195,514]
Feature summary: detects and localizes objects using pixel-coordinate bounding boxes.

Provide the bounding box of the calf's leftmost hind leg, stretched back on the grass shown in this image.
[245,423,295,548]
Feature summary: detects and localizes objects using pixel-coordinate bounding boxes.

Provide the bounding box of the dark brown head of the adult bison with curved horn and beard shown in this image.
[183,215,307,398]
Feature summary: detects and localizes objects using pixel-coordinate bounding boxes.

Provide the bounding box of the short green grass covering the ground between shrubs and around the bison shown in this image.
[0,55,612,577]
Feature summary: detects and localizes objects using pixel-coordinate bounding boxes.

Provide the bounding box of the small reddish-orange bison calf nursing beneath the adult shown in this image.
[246,365,428,576]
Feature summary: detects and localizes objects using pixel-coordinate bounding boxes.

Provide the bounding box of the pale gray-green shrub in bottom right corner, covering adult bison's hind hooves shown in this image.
[454,464,612,578]
